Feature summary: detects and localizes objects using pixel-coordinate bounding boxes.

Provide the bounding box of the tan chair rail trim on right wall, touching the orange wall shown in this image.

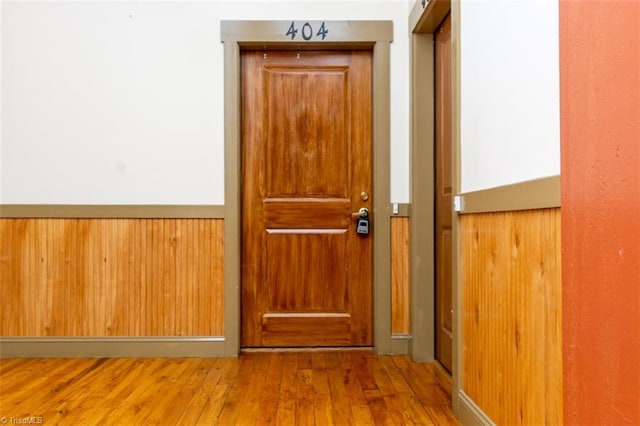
[460,175,560,214]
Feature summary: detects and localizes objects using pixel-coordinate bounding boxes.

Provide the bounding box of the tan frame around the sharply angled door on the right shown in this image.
[409,0,462,413]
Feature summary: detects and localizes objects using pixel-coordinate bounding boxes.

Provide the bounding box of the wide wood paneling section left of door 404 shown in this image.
[0,219,224,337]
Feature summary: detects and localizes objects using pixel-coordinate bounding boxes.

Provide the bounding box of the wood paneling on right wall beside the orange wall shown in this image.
[461,209,562,425]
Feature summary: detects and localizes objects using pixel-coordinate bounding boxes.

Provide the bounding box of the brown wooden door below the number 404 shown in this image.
[241,51,374,347]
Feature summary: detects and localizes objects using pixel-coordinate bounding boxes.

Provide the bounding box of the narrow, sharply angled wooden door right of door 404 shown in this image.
[435,16,453,371]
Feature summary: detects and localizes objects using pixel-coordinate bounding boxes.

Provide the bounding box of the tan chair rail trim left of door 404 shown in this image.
[0,204,224,219]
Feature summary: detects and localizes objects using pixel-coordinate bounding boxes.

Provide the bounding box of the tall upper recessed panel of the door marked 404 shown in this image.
[264,65,350,199]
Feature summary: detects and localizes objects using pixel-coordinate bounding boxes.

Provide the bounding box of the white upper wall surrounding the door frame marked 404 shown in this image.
[0,0,409,205]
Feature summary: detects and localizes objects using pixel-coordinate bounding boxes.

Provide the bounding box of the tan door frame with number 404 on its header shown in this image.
[221,21,393,356]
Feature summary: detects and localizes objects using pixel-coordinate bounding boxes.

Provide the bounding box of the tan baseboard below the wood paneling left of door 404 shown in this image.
[0,336,230,358]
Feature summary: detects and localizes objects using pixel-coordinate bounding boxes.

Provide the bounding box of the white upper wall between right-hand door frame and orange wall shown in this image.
[461,0,560,192]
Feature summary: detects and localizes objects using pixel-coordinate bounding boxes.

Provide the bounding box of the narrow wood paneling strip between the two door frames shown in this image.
[391,217,410,334]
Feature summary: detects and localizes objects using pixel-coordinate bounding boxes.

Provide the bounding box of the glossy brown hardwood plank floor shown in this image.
[0,350,458,425]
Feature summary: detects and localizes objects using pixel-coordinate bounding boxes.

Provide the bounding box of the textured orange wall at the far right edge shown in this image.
[560,0,640,425]
